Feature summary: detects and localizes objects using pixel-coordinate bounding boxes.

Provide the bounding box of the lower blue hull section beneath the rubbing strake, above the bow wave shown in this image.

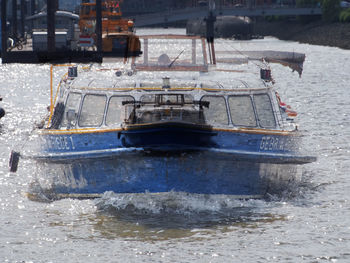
[32,147,306,198]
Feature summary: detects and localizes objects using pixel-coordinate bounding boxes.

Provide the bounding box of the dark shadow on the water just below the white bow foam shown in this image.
[97,196,265,229]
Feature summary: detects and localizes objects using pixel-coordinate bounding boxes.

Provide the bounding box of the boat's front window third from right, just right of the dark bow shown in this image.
[201,96,228,125]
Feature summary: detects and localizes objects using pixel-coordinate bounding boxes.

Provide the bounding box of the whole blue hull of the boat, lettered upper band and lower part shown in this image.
[30,132,313,198]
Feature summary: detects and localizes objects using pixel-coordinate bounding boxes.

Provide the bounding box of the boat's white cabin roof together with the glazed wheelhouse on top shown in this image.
[58,35,290,92]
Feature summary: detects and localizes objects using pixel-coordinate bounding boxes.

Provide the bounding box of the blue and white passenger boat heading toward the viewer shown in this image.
[11,35,316,199]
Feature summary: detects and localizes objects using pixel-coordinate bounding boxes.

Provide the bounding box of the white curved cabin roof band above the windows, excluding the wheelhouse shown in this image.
[69,65,272,92]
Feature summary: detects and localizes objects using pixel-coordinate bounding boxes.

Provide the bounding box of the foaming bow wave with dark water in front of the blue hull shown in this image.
[95,192,284,229]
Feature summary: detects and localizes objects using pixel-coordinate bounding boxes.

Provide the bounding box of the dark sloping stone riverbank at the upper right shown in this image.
[255,21,350,49]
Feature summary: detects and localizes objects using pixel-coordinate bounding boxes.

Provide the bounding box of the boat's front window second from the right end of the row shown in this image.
[228,95,256,127]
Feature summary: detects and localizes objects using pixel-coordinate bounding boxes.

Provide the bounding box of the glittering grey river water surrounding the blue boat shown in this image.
[0,29,350,262]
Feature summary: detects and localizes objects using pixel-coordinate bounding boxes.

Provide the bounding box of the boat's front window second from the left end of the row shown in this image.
[79,94,107,127]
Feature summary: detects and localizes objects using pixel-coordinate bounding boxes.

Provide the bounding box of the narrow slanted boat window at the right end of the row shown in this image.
[254,94,276,128]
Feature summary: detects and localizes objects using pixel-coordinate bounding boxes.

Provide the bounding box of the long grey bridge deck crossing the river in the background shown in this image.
[130,6,322,27]
